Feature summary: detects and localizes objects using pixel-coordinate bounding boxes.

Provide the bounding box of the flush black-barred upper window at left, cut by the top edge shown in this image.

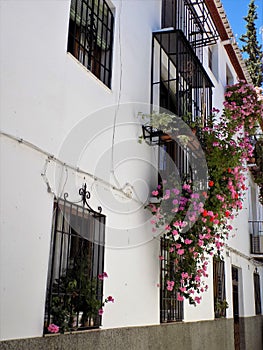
[68,0,114,87]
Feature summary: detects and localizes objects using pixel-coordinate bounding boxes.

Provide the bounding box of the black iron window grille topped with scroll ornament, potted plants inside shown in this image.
[44,185,105,333]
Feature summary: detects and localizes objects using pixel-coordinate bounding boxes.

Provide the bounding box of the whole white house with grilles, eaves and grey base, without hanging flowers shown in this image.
[0,0,263,350]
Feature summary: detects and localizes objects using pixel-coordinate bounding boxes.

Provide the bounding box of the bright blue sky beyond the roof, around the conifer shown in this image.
[221,0,263,46]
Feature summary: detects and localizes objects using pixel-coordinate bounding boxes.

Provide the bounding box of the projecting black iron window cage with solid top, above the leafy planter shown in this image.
[151,30,213,127]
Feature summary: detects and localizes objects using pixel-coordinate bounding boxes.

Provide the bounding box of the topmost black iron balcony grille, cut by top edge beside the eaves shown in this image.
[162,0,219,60]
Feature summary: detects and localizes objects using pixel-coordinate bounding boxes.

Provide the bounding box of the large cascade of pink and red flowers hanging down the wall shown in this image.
[149,82,263,304]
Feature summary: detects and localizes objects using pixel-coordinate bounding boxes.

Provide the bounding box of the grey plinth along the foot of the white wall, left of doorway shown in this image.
[0,318,238,350]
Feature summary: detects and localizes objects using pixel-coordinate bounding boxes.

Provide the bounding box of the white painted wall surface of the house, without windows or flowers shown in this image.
[0,0,263,340]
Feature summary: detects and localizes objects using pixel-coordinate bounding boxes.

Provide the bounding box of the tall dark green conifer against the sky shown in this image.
[240,0,263,86]
